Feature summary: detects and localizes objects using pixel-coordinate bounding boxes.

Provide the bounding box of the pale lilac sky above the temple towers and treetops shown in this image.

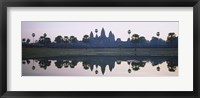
[21,21,179,42]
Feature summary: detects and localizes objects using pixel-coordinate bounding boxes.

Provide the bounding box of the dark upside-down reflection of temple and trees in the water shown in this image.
[22,56,178,75]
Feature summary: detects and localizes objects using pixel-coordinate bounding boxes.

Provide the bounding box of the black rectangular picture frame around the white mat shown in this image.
[0,0,200,98]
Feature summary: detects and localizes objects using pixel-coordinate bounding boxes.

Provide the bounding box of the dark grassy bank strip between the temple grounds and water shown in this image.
[22,48,178,58]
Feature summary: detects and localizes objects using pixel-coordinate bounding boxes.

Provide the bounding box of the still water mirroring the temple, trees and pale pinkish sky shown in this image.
[22,56,178,77]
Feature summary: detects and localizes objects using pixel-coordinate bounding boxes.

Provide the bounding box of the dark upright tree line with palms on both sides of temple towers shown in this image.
[22,29,178,47]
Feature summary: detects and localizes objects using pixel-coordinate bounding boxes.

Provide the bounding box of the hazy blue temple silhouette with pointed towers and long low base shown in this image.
[23,28,178,48]
